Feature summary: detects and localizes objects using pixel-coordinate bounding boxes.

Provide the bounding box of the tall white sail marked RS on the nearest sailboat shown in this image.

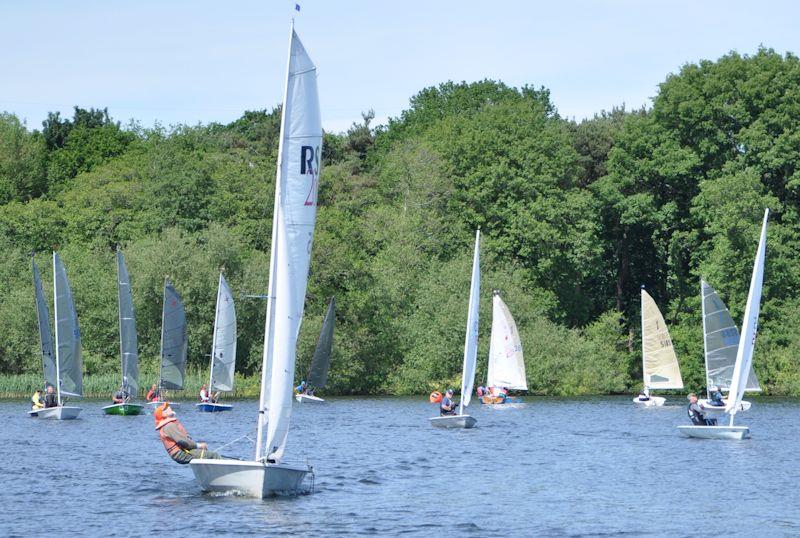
[256,28,322,461]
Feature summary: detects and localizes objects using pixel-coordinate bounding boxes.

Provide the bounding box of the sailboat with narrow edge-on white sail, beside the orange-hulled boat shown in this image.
[428,230,481,428]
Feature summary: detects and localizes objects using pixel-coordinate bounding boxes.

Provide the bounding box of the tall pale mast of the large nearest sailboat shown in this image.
[255,19,294,461]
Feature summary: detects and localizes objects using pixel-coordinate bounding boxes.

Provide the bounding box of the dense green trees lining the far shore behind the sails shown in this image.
[0,49,800,395]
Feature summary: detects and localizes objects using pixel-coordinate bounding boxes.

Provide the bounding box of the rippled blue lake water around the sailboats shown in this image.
[0,397,800,537]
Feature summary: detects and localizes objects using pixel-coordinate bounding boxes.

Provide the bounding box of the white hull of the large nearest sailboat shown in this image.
[189,459,311,499]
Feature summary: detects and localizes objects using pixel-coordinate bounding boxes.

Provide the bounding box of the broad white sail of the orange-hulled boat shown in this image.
[486,291,528,390]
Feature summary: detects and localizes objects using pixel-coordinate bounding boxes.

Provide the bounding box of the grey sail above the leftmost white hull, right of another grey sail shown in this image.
[53,252,83,396]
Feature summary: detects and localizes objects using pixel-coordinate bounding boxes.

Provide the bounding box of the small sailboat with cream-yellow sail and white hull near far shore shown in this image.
[633,287,683,407]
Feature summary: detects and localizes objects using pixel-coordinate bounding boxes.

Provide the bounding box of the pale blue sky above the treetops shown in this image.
[0,0,800,131]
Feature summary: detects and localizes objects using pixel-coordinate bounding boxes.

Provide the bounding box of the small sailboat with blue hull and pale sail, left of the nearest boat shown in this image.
[197,273,236,413]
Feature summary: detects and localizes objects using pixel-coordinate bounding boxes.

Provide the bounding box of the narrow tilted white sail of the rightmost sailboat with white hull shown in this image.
[725,209,769,414]
